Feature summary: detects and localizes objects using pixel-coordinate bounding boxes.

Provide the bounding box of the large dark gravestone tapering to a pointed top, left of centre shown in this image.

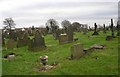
[28,30,46,51]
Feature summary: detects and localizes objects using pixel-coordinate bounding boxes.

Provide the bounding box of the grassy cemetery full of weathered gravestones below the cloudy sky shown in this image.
[0,19,120,75]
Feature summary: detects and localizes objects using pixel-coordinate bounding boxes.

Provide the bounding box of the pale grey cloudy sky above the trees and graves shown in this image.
[0,0,119,28]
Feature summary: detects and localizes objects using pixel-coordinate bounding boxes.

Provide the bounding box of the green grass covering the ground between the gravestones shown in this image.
[2,32,118,75]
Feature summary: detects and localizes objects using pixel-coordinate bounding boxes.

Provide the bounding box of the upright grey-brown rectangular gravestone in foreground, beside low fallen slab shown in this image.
[71,44,85,59]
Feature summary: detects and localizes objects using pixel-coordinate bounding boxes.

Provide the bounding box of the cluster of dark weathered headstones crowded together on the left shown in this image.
[2,30,46,51]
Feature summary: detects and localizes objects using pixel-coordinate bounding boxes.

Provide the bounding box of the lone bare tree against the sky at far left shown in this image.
[3,18,16,31]
